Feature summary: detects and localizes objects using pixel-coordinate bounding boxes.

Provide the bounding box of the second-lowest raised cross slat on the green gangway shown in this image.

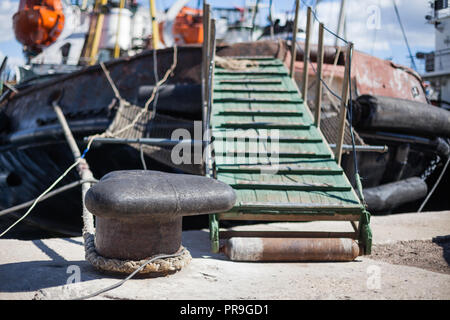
[216,164,343,175]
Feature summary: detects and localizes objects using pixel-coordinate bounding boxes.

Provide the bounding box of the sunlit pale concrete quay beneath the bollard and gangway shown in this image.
[0,211,450,300]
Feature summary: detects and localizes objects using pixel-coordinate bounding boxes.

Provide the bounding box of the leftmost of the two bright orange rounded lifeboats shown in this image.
[13,0,64,53]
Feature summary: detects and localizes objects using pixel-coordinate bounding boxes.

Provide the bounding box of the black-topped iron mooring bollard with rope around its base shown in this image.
[85,170,236,260]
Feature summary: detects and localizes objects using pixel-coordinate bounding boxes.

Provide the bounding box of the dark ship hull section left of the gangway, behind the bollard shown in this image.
[0,46,206,236]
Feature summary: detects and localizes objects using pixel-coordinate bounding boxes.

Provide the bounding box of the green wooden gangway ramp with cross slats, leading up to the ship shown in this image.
[210,57,371,254]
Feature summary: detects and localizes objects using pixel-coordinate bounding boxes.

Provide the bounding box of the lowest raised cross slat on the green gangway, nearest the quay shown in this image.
[230,180,352,191]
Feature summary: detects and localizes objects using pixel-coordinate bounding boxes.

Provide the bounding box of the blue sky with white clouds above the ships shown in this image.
[0,0,434,72]
